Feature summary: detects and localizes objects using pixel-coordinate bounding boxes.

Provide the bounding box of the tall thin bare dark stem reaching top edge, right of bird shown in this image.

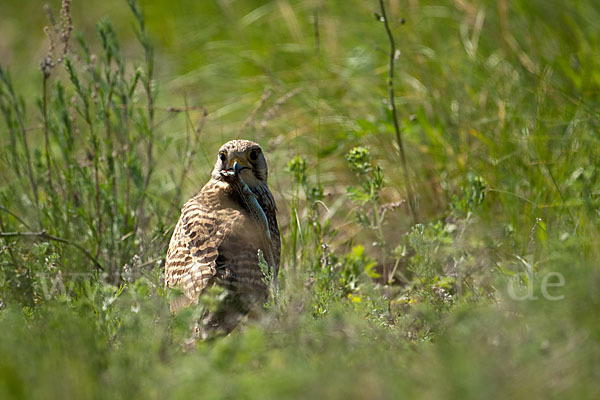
[379,0,418,223]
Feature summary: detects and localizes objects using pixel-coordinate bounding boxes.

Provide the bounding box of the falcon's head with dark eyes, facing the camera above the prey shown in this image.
[212,140,268,188]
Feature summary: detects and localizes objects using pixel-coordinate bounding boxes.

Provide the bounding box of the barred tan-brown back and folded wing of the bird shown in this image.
[165,181,264,311]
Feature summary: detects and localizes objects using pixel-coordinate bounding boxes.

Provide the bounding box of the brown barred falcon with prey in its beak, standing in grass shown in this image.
[165,139,281,334]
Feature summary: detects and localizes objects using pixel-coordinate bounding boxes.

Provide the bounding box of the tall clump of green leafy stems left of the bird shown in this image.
[0,1,169,305]
